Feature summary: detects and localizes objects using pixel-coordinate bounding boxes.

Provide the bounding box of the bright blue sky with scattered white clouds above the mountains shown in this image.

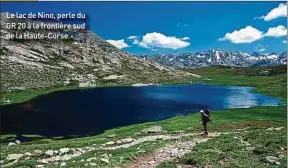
[1,1,287,54]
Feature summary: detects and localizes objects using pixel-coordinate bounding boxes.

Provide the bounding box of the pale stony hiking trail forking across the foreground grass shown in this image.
[2,129,243,168]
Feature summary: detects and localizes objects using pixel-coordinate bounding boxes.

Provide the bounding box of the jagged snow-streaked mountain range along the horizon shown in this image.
[138,49,287,68]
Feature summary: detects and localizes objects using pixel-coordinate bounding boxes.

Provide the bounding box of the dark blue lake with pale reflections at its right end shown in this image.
[1,84,281,136]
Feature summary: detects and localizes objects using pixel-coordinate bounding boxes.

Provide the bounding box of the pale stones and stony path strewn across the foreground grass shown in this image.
[1,126,287,168]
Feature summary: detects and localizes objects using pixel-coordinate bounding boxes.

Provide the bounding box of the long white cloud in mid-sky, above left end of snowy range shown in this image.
[139,32,190,50]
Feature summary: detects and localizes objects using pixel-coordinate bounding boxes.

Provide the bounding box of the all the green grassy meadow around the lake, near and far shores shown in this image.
[0,66,287,168]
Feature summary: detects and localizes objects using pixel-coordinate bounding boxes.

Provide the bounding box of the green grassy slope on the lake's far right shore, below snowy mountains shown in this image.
[184,65,287,100]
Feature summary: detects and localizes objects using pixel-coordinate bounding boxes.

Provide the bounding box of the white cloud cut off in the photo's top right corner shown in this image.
[254,3,287,21]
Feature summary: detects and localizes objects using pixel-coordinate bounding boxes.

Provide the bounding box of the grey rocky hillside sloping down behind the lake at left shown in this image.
[0,13,196,92]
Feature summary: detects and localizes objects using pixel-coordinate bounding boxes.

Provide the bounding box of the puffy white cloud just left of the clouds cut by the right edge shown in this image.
[218,26,263,44]
